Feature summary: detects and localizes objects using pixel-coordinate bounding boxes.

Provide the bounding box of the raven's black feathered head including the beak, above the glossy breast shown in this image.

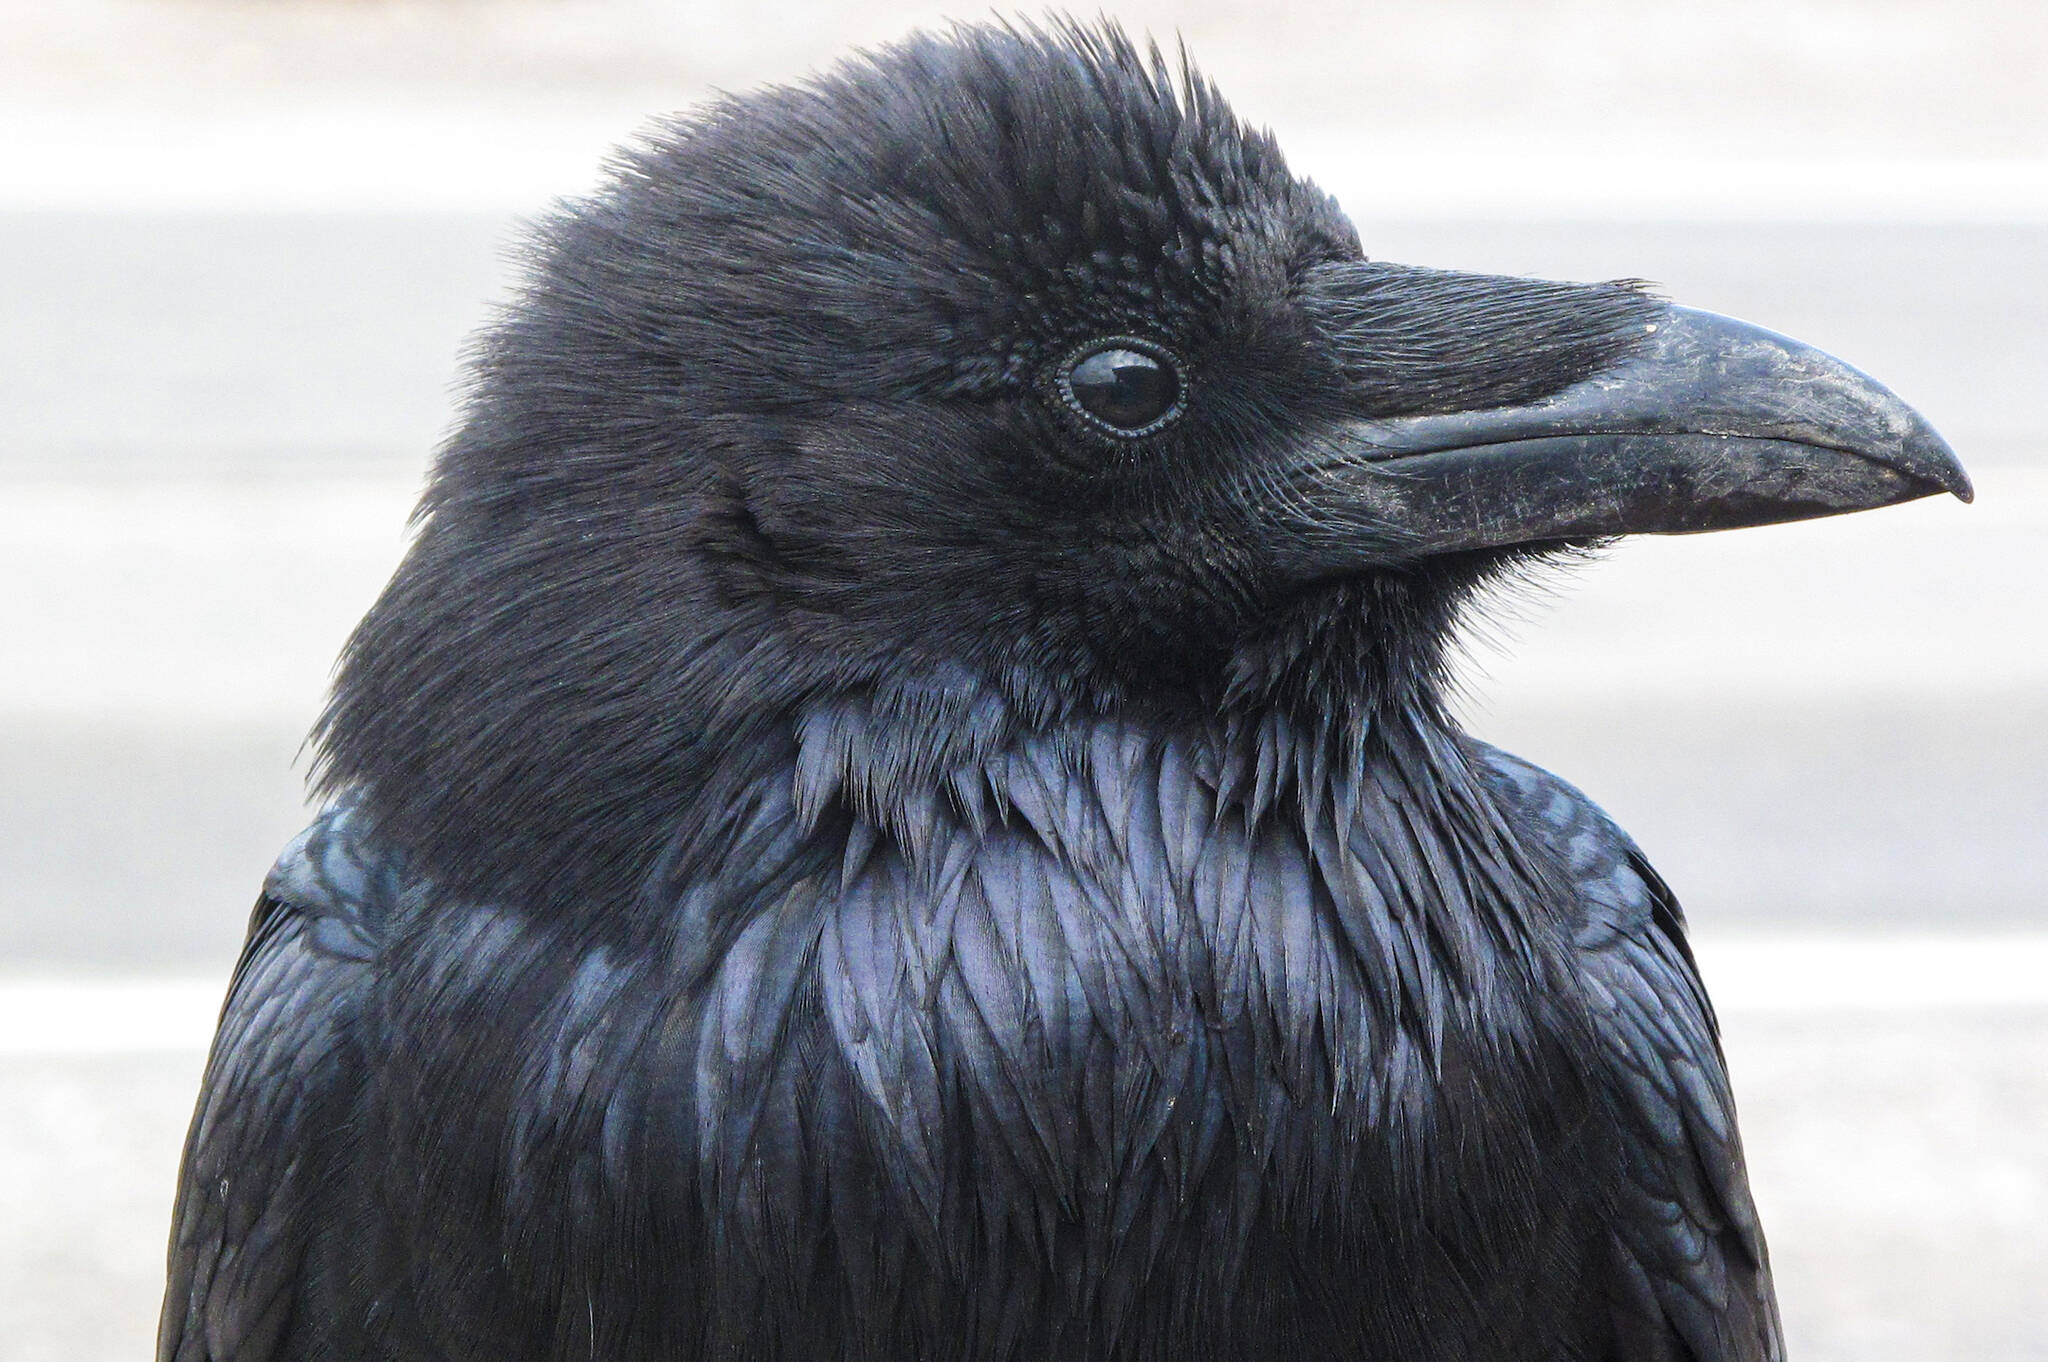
[322,27,1968,891]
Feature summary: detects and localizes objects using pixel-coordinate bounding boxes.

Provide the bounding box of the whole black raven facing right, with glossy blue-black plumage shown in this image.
[160,23,1968,1362]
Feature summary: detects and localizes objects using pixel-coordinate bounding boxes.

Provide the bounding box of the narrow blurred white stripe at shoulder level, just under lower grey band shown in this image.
[0,932,2048,1059]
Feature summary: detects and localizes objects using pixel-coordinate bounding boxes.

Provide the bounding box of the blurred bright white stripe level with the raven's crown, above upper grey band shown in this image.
[0,98,2048,223]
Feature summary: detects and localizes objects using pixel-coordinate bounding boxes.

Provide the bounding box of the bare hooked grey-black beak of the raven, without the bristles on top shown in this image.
[1296,307,1972,571]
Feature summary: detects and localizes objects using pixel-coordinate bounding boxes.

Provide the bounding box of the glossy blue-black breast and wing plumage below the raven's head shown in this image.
[168,723,1776,1358]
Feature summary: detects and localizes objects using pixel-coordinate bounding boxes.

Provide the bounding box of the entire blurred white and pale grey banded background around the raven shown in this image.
[0,0,2048,1362]
